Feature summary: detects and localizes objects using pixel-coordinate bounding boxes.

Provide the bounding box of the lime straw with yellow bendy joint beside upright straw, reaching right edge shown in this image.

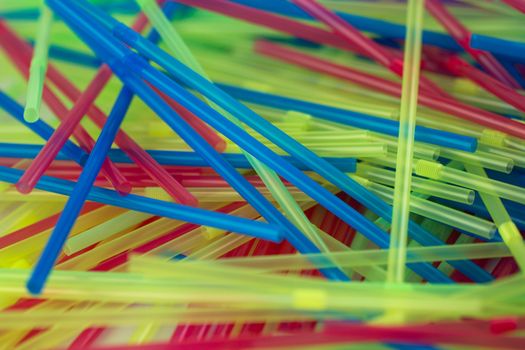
[415,160,525,204]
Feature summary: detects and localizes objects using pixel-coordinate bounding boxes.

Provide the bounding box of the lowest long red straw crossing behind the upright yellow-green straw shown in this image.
[256,41,525,139]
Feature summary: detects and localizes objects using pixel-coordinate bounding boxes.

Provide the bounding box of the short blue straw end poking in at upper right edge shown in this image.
[470,34,525,63]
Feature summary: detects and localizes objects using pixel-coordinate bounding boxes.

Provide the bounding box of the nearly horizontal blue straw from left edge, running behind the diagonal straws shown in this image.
[0,143,356,173]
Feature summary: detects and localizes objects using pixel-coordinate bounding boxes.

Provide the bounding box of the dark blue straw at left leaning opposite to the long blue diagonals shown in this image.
[27,84,133,294]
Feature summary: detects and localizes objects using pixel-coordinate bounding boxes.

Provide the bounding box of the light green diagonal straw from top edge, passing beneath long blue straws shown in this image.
[137,0,329,258]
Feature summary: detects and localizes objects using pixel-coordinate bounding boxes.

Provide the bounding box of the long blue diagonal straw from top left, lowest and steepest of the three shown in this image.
[47,0,352,280]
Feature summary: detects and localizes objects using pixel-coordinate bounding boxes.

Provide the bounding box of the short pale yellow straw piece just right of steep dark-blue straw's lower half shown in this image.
[64,211,151,255]
